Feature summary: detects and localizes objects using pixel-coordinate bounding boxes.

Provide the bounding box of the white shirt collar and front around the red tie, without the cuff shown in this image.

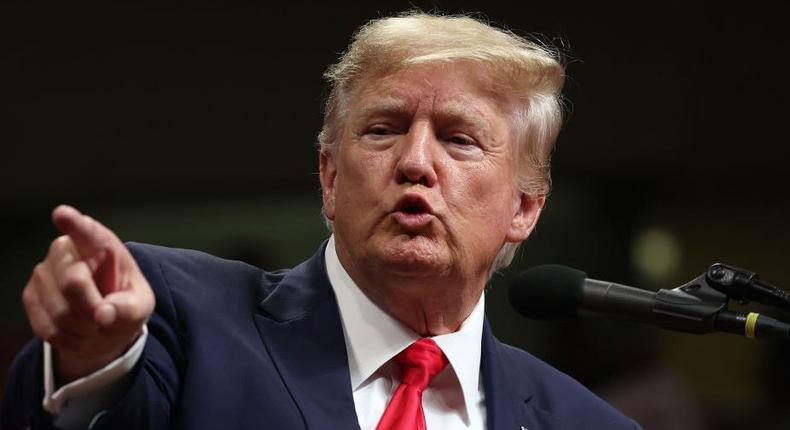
[326,236,486,430]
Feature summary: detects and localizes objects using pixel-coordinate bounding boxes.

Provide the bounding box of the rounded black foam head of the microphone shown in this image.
[509,264,587,319]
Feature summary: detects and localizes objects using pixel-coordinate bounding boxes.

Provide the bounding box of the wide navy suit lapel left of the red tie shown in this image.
[255,243,359,429]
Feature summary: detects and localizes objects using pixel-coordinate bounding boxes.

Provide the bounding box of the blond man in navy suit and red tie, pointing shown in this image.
[3,13,638,430]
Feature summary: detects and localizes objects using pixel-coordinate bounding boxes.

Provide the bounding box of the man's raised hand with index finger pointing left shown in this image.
[22,205,154,384]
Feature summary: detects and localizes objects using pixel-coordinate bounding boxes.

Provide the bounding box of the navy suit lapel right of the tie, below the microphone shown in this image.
[480,319,563,430]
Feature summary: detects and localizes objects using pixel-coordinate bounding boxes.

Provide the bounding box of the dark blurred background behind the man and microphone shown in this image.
[0,0,790,430]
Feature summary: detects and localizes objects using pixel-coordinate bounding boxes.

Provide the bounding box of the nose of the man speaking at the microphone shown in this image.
[395,123,438,187]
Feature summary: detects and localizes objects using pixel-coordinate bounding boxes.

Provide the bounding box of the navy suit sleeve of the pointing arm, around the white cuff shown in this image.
[0,244,185,430]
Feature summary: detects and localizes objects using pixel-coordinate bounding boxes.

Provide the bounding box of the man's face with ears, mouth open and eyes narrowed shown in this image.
[321,63,542,288]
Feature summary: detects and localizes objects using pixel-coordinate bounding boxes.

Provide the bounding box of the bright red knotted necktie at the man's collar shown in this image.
[376,338,447,430]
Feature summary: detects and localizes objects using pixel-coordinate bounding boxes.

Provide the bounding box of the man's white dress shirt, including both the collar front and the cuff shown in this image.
[43,236,486,430]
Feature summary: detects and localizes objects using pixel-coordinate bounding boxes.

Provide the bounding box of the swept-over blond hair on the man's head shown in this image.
[318,12,565,269]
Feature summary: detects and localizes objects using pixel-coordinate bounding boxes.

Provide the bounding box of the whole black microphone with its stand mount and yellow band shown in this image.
[509,264,790,339]
